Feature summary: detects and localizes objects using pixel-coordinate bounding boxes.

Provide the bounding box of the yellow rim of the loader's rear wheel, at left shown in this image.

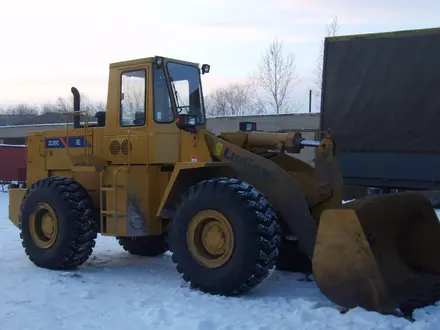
[29,202,58,249]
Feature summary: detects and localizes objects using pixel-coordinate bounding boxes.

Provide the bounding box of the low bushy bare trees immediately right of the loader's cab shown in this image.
[205,83,257,117]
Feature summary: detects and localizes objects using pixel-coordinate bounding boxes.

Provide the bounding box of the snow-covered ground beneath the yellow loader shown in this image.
[0,192,440,330]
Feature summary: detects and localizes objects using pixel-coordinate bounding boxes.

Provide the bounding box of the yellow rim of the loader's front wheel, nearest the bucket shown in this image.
[187,210,234,268]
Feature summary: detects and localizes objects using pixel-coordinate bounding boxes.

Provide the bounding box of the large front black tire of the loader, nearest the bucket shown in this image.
[168,178,280,296]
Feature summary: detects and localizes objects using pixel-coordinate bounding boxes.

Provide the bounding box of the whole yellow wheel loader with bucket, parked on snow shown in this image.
[9,56,440,315]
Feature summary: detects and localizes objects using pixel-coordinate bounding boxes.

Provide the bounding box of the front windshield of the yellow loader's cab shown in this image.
[167,62,205,125]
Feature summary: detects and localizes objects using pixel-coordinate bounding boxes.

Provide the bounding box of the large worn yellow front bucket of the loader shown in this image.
[312,193,440,316]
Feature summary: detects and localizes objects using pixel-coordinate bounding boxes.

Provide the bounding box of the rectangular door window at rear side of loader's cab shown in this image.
[120,70,147,127]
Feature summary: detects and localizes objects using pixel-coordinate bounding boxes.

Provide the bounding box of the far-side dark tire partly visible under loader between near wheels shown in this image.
[117,235,168,257]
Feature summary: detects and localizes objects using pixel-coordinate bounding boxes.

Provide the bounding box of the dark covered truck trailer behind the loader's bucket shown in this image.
[320,28,440,201]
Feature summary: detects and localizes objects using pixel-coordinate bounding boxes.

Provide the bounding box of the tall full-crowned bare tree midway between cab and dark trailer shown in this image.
[253,38,301,114]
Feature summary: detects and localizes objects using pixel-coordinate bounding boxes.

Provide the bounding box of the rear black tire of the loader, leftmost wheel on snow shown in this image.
[19,177,97,270]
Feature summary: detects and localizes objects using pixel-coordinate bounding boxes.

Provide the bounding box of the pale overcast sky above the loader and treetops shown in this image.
[0,0,440,104]
